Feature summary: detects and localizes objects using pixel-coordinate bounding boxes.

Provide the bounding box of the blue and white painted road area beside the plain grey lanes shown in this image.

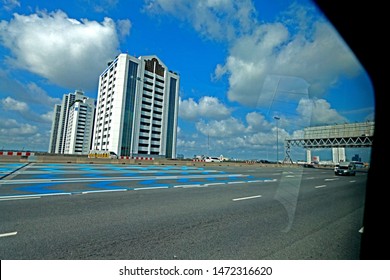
[0,164,274,195]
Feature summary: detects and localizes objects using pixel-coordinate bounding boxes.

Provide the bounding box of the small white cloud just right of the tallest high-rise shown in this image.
[179,96,231,120]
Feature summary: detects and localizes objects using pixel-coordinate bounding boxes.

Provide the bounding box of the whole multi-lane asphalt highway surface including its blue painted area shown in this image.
[0,163,367,260]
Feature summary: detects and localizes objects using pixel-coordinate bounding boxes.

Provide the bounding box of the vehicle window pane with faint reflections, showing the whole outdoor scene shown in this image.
[0,0,375,274]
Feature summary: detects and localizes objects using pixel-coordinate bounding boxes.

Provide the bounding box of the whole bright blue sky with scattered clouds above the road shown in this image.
[0,0,375,161]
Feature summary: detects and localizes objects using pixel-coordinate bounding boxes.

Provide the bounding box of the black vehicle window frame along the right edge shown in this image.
[314,0,389,260]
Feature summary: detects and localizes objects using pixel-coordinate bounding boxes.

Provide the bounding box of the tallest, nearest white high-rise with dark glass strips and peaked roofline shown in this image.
[92,54,180,158]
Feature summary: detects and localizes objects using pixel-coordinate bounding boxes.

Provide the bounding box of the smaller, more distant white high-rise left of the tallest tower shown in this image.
[49,90,95,154]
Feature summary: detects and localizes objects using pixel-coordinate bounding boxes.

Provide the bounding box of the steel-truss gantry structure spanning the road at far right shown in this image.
[284,122,375,163]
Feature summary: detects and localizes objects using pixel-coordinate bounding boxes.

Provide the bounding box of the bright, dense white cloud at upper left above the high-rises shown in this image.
[0,11,131,90]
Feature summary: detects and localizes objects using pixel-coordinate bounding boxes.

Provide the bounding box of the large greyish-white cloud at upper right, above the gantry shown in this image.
[215,17,362,107]
